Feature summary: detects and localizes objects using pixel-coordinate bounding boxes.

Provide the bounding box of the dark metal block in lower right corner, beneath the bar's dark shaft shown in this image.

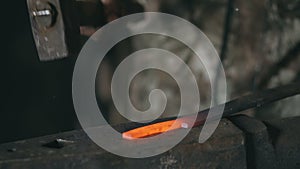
[230,115,300,169]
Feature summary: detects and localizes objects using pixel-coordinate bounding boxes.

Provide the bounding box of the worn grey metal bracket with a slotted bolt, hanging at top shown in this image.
[27,0,80,61]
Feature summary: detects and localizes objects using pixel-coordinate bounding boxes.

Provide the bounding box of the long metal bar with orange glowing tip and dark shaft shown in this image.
[122,82,300,140]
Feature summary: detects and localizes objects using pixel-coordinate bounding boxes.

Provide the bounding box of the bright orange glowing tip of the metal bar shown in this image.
[122,120,182,140]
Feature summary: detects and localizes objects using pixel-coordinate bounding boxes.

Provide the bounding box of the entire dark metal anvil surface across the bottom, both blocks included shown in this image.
[0,116,300,169]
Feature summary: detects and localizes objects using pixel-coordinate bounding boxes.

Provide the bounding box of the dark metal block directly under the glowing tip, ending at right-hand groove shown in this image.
[0,119,246,169]
